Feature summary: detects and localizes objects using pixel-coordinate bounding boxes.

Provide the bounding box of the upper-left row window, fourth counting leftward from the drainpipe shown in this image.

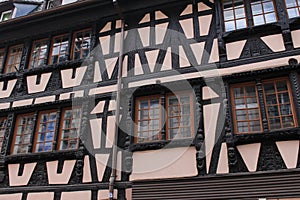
[4,45,23,73]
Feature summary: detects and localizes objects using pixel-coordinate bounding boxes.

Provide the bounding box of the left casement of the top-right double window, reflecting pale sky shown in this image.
[223,0,247,31]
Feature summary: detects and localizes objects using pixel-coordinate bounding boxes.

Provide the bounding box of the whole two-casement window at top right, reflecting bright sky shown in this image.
[223,0,277,31]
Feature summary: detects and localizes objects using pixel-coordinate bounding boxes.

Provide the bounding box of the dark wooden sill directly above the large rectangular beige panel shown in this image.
[130,138,194,152]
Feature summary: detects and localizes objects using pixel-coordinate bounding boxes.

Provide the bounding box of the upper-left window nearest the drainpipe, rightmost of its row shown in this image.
[72,29,91,60]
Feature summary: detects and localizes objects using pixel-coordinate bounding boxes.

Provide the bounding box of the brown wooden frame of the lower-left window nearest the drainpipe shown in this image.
[57,107,82,151]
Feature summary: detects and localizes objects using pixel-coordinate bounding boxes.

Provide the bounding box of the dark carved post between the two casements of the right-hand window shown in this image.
[256,79,269,131]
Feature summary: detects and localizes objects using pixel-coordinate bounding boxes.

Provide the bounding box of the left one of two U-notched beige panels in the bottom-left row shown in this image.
[8,163,36,186]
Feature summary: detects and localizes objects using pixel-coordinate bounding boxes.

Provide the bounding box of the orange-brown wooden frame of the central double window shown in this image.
[134,91,195,144]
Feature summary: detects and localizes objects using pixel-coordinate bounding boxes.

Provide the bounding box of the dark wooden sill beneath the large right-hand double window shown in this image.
[234,127,300,145]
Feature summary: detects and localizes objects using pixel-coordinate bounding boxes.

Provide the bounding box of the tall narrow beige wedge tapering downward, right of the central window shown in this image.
[203,103,220,173]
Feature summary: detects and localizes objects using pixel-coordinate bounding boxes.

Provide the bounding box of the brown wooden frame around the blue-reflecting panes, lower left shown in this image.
[32,109,58,153]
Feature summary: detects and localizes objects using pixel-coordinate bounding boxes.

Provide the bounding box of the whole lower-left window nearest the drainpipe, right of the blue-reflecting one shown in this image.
[59,108,81,150]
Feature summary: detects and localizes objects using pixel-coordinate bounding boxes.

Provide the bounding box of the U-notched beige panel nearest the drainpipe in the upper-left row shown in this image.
[60,66,87,88]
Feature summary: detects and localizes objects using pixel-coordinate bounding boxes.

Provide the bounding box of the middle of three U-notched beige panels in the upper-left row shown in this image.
[26,73,52,94]
